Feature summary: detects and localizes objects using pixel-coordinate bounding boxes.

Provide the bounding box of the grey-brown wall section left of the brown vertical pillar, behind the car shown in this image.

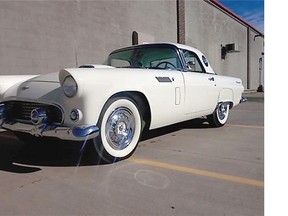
[0,0,177,74]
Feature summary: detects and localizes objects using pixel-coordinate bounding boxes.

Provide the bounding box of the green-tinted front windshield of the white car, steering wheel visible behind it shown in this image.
[105,46,182,70]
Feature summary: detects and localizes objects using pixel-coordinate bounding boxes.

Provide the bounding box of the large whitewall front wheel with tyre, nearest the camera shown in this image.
[94,97,142,163]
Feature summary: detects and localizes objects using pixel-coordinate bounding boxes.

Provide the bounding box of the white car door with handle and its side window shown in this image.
[183,51,218,116]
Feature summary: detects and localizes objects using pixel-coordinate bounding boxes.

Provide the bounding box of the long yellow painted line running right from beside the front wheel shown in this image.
[128,157,264,188]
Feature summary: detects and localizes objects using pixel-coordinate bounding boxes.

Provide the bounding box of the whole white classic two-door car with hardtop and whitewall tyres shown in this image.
[0,43,244,162]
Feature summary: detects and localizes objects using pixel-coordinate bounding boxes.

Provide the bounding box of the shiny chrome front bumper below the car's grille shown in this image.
[0,122,99,141]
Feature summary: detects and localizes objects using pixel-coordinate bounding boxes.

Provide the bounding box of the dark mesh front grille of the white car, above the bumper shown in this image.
[4,101,63,124]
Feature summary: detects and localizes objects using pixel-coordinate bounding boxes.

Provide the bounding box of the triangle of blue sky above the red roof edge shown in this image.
[219,0,264,33]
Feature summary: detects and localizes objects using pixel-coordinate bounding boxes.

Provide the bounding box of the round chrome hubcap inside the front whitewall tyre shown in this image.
[105,107,135,150]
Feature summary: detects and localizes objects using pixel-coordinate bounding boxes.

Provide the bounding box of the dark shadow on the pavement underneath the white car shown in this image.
[0,119,210,173]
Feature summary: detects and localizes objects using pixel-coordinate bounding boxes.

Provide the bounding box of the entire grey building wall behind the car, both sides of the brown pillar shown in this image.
[0,0,264,89]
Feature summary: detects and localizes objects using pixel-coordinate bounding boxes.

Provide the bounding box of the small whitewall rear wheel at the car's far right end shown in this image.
[207,103,230,127]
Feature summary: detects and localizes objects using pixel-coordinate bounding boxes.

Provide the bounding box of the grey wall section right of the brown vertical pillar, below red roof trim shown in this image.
[185,0,263,89]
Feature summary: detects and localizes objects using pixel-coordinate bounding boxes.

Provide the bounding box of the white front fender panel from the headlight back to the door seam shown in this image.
[59,68,184,129]
